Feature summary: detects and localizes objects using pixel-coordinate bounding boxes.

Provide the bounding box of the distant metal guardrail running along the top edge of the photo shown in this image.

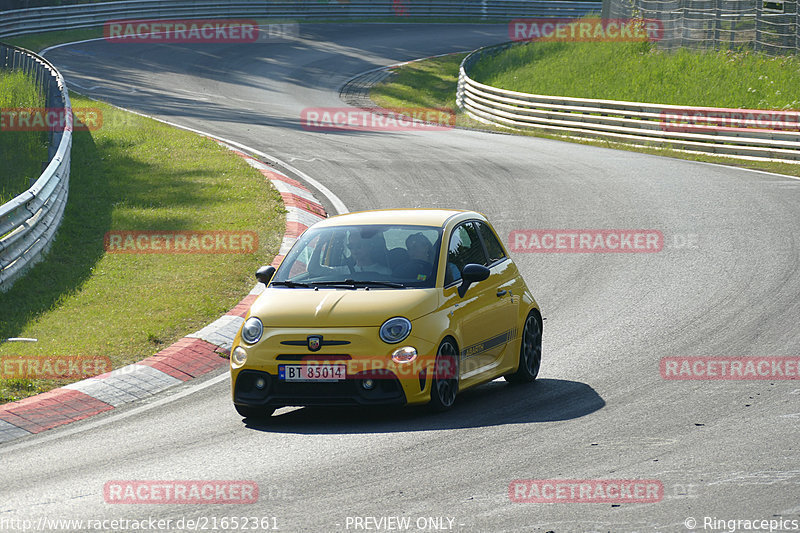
[0,0,602,37]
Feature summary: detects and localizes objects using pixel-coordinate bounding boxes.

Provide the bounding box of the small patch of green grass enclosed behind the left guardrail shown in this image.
[0,72,47,204]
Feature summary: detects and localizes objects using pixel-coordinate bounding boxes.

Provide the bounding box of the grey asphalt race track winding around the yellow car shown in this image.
[0,24,800,533]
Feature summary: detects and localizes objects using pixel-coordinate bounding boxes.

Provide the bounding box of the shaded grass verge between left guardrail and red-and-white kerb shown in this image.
[0,95,285,402]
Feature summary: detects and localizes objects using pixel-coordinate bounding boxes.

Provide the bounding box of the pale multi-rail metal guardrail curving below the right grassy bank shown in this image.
[456,43,800,162]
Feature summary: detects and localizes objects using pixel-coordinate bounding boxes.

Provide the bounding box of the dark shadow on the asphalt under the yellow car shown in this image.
[244,379,605,435]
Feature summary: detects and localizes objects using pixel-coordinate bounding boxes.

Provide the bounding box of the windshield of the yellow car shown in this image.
[272,225,442,289]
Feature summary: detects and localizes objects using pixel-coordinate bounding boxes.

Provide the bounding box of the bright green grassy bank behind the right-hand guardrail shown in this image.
[470,42,800,109]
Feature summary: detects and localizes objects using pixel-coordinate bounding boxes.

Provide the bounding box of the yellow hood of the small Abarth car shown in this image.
[250,288,439,328]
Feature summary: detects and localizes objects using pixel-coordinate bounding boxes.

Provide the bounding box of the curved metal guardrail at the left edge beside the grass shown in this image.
[0,44,72,290]
